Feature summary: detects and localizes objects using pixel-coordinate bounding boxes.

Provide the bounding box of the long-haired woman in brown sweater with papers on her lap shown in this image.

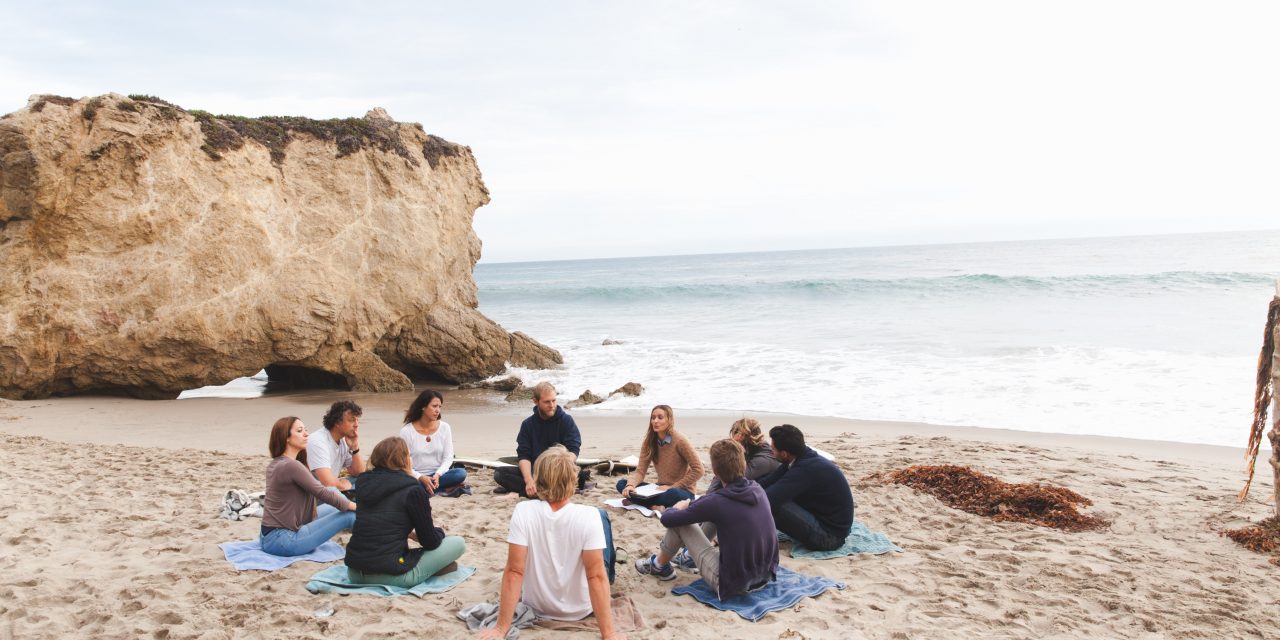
[618,404,703,508]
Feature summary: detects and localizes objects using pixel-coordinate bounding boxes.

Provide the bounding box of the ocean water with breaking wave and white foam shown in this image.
[475,232,1280,447]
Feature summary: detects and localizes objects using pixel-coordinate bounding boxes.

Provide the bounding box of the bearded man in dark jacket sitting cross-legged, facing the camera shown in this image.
[493,381,591,498]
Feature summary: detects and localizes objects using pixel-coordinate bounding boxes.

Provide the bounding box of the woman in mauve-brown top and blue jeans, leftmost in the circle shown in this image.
[261,416,356,556]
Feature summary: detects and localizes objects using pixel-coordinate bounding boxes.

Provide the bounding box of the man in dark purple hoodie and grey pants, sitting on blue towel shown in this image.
[636,439,778,600]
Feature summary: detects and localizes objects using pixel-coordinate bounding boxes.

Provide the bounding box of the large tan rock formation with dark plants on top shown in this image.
[0,93,561,398]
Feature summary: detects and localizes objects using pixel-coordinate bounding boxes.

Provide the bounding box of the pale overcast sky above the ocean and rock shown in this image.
[0,0,1280,261]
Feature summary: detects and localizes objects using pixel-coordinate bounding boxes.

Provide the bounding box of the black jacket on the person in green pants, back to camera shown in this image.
[347,467,444,576]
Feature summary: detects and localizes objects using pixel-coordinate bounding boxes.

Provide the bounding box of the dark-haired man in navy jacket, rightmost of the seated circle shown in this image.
[760,425,854,550]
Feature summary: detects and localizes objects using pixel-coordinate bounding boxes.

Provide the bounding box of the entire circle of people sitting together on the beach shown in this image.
[254,383,855,637]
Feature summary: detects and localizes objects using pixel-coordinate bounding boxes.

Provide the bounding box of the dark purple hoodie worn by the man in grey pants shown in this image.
[662,477,778,600]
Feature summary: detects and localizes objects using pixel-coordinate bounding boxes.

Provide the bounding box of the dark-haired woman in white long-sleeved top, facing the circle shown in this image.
[399,389,471,498]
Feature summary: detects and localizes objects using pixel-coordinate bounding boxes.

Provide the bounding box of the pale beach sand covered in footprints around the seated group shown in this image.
[0,392,1280,639]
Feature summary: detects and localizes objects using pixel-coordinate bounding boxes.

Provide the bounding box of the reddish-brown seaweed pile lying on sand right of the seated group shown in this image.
[882,465,1108,531]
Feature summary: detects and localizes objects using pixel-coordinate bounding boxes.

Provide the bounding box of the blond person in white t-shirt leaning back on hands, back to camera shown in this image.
[480,445,622,639]
